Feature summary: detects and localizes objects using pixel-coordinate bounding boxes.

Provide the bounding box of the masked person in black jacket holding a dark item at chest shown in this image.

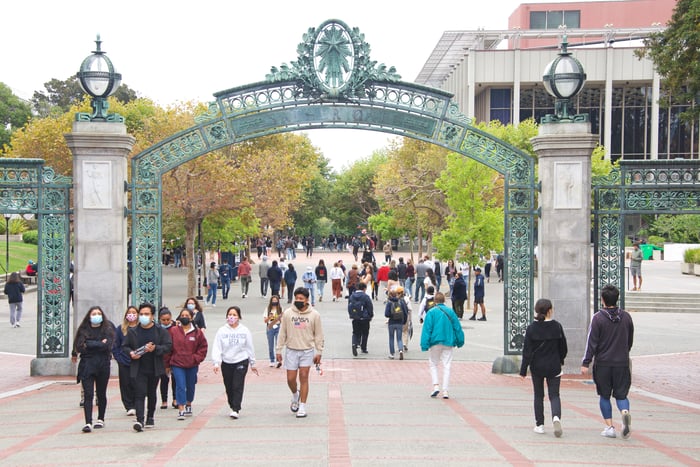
[123,303,173,432]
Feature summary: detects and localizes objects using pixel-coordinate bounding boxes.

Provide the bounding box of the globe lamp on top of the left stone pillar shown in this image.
[75,34,124,122]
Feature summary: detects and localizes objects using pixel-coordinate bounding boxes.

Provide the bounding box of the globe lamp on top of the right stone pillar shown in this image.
[541,35,588,123]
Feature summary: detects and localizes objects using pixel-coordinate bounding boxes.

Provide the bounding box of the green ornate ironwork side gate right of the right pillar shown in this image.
[593,160,700,306]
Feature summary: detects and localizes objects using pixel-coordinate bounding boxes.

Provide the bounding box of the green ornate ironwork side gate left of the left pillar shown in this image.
[0,159,72,358]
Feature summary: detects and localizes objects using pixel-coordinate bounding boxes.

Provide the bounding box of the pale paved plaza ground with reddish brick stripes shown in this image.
[0,251,700,466]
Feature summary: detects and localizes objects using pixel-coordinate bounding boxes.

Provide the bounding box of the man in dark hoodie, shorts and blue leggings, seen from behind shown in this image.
[581,284,634,439]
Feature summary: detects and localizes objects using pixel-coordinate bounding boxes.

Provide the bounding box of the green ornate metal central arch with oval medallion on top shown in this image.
[130,20,537,354]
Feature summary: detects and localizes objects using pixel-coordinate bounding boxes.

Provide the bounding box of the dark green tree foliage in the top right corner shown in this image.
[637,0,700,122]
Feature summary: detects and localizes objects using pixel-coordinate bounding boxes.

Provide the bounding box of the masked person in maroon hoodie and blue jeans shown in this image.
[165,308,209,420]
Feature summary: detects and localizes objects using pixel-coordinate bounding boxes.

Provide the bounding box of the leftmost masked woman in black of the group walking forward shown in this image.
[71,306,114,433]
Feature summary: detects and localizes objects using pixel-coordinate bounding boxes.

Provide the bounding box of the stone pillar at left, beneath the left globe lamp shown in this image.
[66,121,135,328]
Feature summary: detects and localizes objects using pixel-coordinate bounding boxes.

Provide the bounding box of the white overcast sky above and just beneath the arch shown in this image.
[0,0,580,170]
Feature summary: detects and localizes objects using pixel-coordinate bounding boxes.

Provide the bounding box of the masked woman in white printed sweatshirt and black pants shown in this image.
[211,306,258,420]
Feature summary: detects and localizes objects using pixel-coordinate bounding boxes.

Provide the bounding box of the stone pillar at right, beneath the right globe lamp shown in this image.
[532,123,598,373]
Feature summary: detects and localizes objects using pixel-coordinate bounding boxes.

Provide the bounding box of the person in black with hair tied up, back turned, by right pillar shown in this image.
[520,298,568,438]
